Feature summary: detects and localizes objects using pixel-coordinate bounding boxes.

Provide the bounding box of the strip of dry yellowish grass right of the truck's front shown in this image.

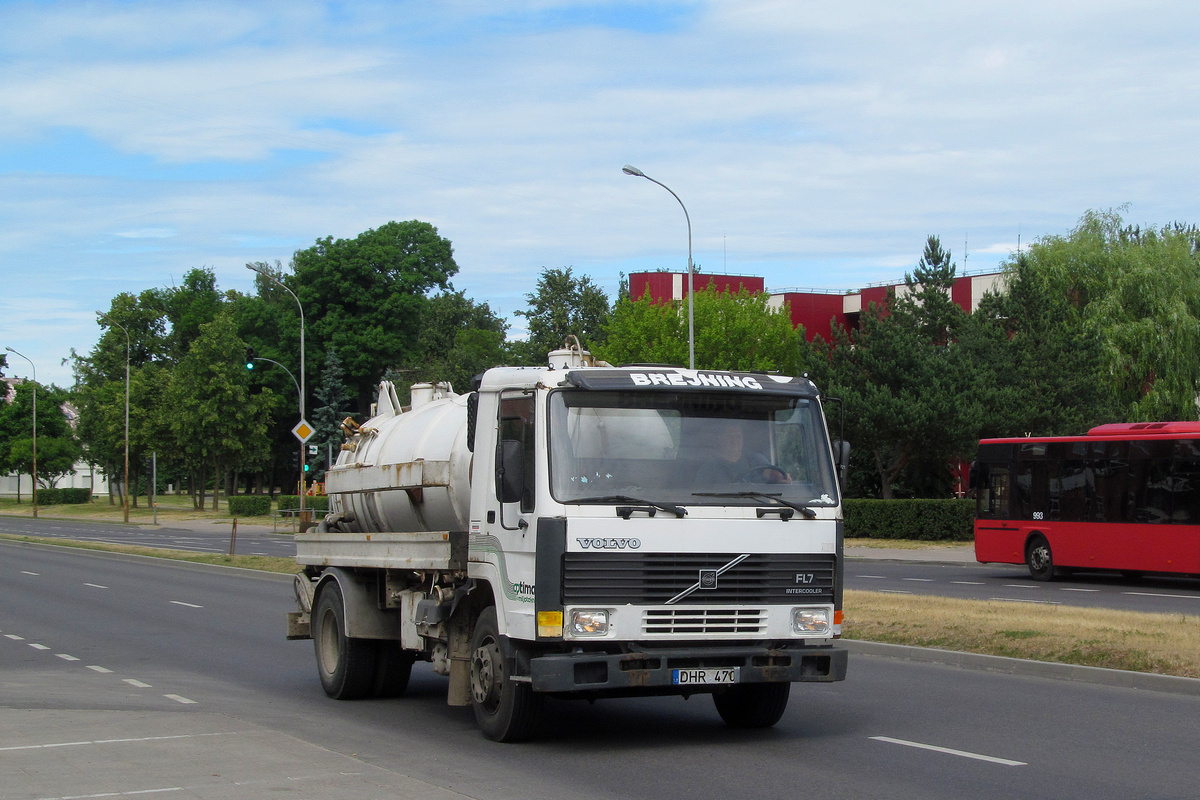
[842,590,1200,678]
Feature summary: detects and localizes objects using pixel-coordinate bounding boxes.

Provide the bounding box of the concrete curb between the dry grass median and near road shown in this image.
[840,639,1200,697]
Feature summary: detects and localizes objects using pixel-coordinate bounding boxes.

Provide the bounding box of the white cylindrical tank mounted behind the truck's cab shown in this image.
[325,381,472,533]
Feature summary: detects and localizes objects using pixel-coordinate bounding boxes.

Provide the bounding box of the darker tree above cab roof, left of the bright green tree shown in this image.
[512,266,612,365]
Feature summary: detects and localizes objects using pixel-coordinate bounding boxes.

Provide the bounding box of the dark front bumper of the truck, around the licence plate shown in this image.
[529,646,847,694]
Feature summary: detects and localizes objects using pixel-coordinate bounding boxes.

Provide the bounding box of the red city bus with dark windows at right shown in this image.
[971,422,1200,581]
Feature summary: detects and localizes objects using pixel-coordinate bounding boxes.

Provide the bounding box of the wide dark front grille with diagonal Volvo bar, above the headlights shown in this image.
[563,552,836,606]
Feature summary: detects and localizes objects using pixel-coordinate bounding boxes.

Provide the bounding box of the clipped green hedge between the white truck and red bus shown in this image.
[845,499,974,542]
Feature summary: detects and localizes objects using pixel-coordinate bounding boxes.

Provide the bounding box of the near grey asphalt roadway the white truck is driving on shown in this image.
[0,542,1200,800]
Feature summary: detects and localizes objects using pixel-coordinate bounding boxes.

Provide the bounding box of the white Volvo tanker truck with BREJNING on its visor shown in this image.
[288,347,847,741]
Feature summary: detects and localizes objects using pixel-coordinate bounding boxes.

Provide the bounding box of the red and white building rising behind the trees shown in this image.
[629,272,1004,342]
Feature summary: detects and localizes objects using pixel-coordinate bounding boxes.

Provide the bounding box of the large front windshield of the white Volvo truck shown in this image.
[550,390,838,507]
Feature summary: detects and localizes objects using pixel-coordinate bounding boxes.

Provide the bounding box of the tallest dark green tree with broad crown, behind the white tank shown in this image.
[284,219,458,410]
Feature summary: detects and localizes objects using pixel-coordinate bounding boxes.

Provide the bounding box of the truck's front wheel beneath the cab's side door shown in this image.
[470,606,544,741]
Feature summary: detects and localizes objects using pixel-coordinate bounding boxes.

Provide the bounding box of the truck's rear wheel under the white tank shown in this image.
[312,581,379,700]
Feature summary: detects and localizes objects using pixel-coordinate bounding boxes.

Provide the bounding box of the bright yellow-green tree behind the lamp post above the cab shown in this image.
[596,287,805,375]
